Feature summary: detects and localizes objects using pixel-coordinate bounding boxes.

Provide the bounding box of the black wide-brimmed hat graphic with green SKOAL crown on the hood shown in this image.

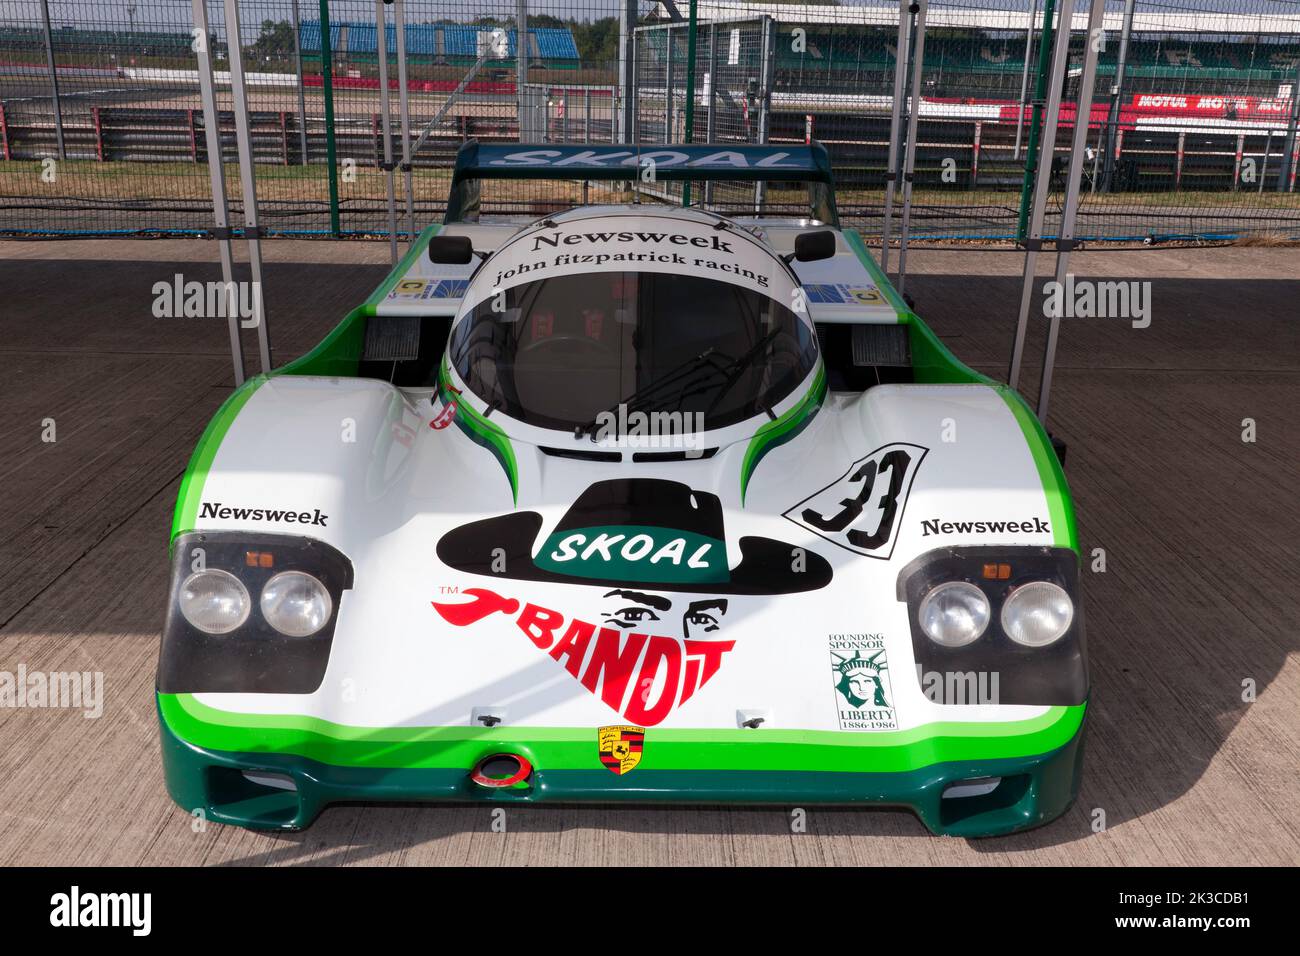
[438,479,832,594]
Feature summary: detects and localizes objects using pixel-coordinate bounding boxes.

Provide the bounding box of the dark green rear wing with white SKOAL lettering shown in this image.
[443,139,840,226]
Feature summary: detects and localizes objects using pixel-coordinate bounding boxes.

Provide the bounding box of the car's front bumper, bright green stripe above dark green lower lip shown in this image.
[159,695,1086,836]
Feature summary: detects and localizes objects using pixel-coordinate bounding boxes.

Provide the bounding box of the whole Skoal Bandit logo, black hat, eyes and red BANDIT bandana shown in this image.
[433,479,831,727]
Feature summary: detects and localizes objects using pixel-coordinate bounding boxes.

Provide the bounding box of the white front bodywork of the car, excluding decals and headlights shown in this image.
[188,376,1053,732]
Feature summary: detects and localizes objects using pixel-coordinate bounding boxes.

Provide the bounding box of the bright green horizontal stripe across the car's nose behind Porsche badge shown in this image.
[159,693,1087,773]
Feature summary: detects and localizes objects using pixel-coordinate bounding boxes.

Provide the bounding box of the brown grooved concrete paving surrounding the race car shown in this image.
[0,239,1300,866]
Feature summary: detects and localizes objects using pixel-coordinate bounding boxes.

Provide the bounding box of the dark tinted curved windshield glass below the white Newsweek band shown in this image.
[449,272,816,432]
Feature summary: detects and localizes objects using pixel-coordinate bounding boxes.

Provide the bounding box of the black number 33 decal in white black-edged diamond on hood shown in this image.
[785,442,928,559]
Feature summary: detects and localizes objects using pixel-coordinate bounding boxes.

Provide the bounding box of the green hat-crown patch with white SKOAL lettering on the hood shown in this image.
[537,525,728,584]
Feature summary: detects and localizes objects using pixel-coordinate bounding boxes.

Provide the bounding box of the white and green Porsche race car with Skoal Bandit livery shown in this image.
[157,143,1088,835]
